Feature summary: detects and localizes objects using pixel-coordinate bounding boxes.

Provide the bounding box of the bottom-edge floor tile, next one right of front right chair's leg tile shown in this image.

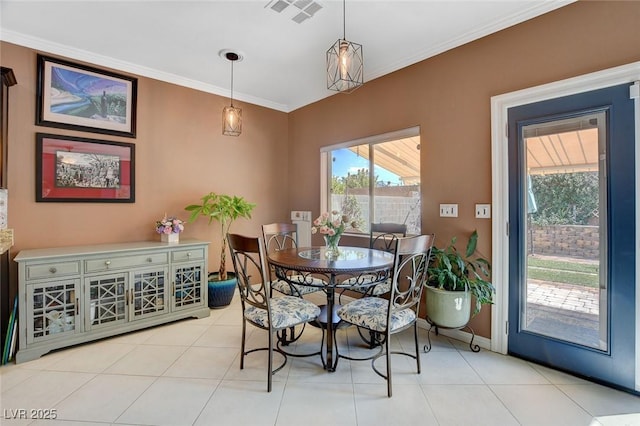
[422,385,516,426]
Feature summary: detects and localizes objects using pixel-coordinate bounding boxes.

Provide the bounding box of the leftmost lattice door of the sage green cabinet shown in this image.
[26,278,82,343]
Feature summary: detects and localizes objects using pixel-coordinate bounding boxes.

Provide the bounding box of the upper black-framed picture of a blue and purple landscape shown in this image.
[36,55,138,138]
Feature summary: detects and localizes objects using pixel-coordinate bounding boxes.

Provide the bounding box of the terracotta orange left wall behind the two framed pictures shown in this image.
[0,43,289,276]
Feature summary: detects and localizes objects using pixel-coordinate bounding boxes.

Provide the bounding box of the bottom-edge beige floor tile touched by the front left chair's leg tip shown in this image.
[195,380,284,426]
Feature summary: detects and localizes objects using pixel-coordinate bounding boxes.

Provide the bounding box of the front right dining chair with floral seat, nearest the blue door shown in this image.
[338,234,435,397]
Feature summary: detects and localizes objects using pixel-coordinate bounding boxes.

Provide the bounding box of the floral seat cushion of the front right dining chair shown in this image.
[338,297,416,333]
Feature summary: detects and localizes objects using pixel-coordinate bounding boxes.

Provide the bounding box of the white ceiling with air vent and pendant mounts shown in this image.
[0,0,574,112]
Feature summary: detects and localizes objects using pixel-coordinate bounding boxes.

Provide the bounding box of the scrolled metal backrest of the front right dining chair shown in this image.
[387,234,435,324]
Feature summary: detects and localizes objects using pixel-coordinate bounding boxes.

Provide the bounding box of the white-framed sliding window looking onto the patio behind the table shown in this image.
[321,127,421,234]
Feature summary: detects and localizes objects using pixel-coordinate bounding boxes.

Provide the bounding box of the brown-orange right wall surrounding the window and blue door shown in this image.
[289,1,640,337]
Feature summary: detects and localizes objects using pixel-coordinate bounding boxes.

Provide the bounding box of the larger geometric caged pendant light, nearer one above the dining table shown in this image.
[327,0,364,93]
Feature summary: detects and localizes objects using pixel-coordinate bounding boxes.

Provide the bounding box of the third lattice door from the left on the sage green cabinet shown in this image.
[129,267,169,321]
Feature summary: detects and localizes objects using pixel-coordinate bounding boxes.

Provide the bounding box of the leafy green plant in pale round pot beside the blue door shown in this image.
[426,231,495,328]
